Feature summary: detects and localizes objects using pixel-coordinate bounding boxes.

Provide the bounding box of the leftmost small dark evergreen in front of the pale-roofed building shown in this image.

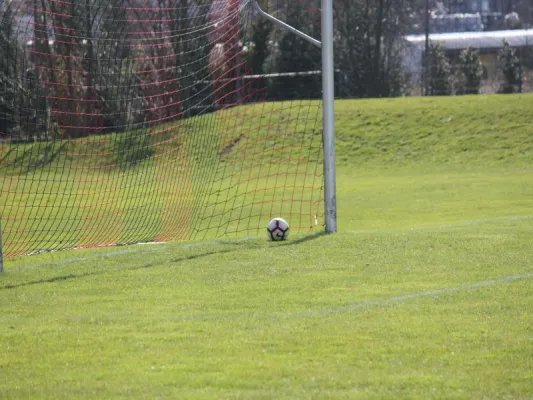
[424,42,452,96]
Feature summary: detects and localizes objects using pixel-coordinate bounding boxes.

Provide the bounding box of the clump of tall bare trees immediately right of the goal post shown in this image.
[333,0,417,97]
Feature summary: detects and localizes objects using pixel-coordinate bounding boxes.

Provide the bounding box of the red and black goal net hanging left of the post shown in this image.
[0,0,324,258]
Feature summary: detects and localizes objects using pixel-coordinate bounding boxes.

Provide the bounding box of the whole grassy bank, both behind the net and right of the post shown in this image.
[2,94,533,174]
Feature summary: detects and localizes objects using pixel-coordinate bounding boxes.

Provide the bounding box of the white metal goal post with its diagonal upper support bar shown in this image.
[252,0,337,233]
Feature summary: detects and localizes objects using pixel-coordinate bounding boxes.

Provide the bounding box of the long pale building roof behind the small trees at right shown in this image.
[405,29,533,50]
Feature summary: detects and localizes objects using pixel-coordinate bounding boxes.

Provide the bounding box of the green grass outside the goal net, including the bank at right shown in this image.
[0,95,533,399]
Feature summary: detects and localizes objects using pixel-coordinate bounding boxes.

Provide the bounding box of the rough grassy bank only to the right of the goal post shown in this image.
[337,95,533,168]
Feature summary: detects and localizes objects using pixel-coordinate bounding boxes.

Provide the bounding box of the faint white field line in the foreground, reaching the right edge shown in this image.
[290,272,533,318]
